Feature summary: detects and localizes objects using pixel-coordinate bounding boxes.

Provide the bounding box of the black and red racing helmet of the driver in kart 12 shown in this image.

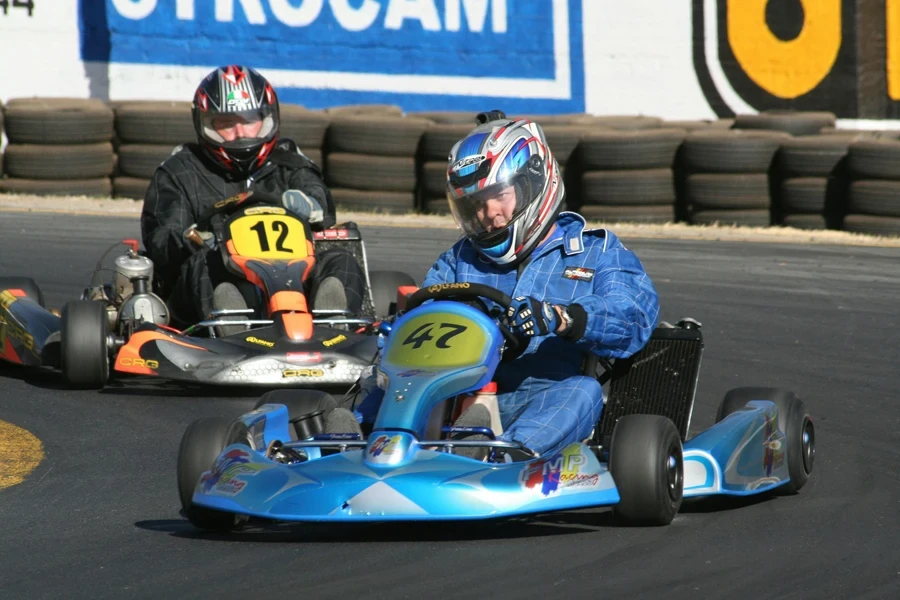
[191,65,280,178]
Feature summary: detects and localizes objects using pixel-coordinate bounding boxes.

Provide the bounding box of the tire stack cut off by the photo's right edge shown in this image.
[842,139,900,235]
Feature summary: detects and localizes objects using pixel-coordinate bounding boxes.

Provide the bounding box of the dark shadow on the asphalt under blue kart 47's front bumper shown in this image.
[135,510,618,543]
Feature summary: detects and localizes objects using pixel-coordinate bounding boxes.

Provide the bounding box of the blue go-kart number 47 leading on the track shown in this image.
[178,283,815,531]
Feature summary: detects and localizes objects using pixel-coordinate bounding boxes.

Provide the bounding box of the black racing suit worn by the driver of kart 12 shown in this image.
[141,138,365,326]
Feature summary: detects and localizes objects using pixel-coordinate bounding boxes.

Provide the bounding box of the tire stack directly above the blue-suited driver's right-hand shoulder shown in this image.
[578,117,687,223]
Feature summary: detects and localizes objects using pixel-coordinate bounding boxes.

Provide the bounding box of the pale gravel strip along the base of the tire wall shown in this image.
[0,194,900,248]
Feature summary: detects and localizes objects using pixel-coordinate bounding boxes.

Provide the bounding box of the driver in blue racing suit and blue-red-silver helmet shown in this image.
[360,113,659,455]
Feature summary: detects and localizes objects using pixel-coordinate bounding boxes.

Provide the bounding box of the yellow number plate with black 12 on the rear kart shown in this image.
[229,215,309,258]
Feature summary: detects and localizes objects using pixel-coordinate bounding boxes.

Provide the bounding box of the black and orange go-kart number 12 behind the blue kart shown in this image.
[0,192,415,389]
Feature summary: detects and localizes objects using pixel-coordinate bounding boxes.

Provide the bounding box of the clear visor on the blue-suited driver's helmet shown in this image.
[448,174,540,241]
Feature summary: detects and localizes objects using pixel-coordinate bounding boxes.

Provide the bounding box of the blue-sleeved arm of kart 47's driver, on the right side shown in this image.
[564,247,659,358]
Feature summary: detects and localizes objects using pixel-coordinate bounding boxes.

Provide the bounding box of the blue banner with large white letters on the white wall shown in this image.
[80,0,584,113]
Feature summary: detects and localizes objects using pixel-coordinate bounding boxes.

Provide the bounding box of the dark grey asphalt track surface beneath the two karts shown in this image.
[0,213,900,599]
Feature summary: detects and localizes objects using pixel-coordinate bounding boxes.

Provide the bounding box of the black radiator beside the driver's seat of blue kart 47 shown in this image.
[595,322,703,448]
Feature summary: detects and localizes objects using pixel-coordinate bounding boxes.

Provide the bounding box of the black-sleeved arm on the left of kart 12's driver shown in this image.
[141,167,197,279]
